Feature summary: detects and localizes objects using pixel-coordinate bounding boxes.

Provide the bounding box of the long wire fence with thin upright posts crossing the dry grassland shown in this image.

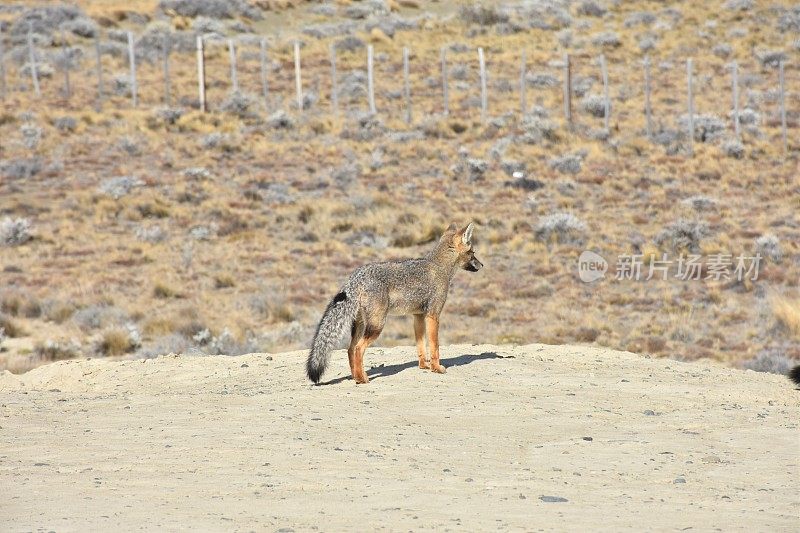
[0,28,800,156]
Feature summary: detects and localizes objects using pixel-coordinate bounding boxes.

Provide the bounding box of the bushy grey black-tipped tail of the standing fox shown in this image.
[306,291,358,383]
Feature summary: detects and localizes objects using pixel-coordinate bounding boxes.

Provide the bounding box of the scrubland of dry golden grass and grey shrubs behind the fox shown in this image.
[0,0,800,379]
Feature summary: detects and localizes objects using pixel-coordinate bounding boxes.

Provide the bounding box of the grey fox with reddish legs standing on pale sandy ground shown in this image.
[306,222,483,384]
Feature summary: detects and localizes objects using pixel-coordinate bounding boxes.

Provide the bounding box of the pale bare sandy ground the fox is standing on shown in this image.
[0,345,800,531]
